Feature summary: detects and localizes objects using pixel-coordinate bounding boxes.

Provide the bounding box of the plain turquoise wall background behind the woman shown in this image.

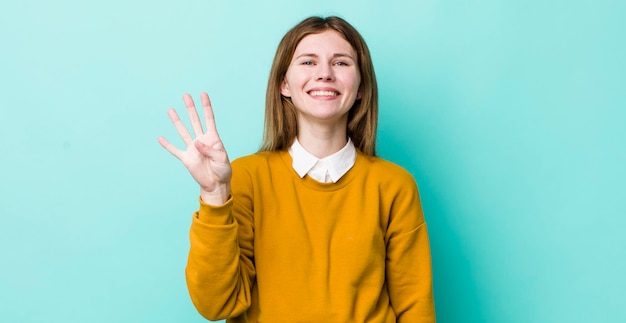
[0,0,626,323]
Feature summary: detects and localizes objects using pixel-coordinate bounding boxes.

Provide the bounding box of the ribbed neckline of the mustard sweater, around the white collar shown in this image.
[278,149,366,192]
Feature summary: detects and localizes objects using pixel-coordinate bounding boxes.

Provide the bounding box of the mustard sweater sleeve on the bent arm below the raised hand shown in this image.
[185,161,255,320]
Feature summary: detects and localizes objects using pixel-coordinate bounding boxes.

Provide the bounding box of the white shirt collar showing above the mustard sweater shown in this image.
[289,138,356,183]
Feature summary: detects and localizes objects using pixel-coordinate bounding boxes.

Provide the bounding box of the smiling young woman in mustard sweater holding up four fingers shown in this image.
[159,17,435,323]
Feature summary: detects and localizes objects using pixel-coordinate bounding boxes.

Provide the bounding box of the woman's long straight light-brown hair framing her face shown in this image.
[260,16,378,156]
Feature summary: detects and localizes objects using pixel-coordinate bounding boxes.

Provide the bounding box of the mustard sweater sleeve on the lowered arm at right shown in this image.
[386,177,436,323]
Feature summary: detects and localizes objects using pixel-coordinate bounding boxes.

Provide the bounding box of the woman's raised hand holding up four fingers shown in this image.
[159,92,232,205]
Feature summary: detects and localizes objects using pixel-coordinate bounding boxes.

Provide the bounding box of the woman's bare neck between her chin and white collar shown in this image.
[298,119,348,158]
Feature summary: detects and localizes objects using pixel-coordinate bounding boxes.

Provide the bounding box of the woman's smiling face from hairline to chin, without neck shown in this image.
[280,30,361,126]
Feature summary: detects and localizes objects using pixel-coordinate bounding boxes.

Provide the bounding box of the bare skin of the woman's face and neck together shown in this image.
[281,30,361,158]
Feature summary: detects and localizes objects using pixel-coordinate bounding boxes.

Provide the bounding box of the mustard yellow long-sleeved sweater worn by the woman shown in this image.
[186,151,435,323]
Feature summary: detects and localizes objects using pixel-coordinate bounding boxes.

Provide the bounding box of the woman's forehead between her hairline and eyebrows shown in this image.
[294,30,356,57]
